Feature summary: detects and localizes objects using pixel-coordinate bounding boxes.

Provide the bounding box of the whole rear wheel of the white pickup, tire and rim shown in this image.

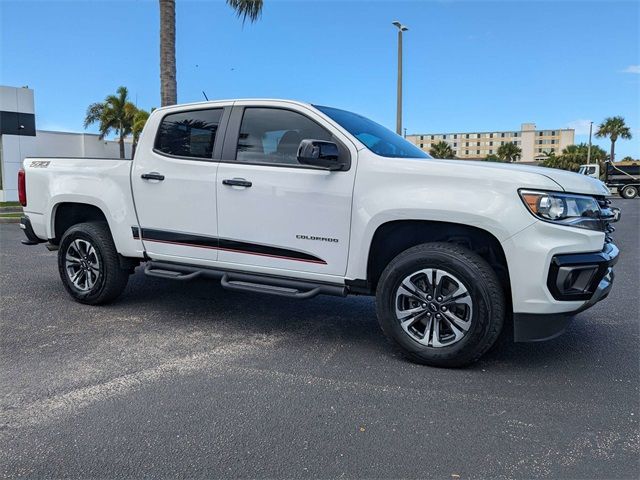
[58,222,129,305]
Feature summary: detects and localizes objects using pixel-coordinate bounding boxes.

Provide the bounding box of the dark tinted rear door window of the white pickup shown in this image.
[155,108,222,159]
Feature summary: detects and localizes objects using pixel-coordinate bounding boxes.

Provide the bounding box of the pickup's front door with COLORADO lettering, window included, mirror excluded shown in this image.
[217,102,357,275]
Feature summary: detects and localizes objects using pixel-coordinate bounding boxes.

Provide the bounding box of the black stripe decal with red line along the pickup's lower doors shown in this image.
[131,227,327,265]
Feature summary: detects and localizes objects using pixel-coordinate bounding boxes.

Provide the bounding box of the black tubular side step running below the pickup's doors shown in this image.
[144,262,347,299]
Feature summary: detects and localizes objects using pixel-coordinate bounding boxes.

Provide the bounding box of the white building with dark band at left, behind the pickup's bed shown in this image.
[0,86,131,202]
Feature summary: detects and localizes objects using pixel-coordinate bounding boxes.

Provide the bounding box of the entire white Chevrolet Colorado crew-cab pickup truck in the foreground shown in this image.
[19,100,619,366]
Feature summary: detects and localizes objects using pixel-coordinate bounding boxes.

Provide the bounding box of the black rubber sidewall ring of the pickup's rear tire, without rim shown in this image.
[58,226,108,303]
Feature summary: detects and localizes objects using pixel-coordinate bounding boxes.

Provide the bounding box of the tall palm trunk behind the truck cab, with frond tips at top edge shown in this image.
[159,0,262,107]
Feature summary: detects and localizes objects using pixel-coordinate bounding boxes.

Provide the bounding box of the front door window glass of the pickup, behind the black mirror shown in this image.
[236,107,335,165]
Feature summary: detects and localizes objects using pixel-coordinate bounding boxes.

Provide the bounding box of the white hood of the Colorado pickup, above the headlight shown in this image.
[428,159,610,195]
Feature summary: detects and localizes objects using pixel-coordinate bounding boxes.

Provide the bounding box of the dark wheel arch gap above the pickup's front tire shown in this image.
[366,220,511,298]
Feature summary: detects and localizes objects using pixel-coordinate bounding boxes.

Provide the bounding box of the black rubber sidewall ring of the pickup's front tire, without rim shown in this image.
[377,249,498,366]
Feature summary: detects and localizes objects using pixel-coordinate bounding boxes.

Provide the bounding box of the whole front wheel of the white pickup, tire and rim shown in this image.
[376,243,505,367]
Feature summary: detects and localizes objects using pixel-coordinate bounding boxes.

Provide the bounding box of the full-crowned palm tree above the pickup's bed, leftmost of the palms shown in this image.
[84,87,137,158]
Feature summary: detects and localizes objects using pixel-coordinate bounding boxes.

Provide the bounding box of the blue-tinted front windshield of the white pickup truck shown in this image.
[314,105,431,158]
